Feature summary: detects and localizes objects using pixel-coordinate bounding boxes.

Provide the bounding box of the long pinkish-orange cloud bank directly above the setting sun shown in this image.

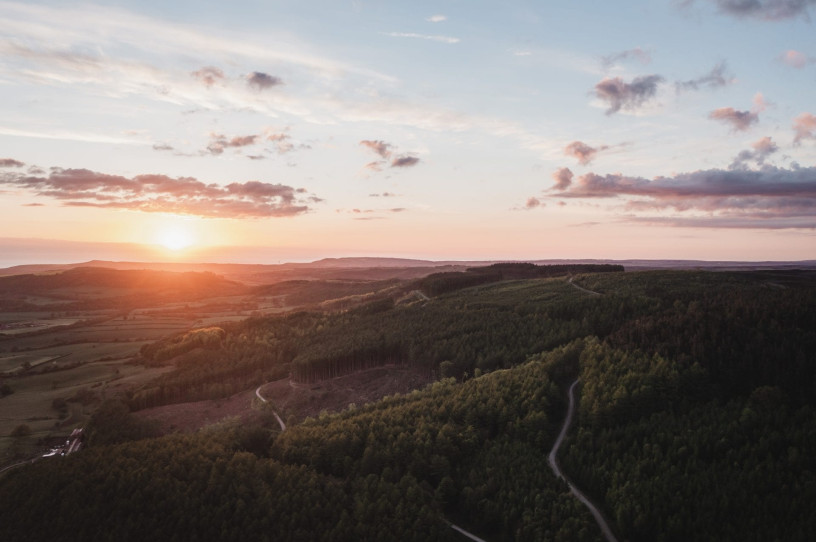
[0,168,321,218]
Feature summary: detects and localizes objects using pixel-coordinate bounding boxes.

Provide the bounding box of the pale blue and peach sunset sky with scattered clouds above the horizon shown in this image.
[0,0,816,266]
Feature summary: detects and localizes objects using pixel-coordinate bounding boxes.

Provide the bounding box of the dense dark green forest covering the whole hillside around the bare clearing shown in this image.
[0,271,816,541]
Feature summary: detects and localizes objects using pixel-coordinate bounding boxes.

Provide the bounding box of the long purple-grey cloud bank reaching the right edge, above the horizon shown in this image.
[552,164,816,229]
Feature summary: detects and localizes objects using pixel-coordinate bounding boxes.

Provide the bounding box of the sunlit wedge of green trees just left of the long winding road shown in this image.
[272,344,599,540]
